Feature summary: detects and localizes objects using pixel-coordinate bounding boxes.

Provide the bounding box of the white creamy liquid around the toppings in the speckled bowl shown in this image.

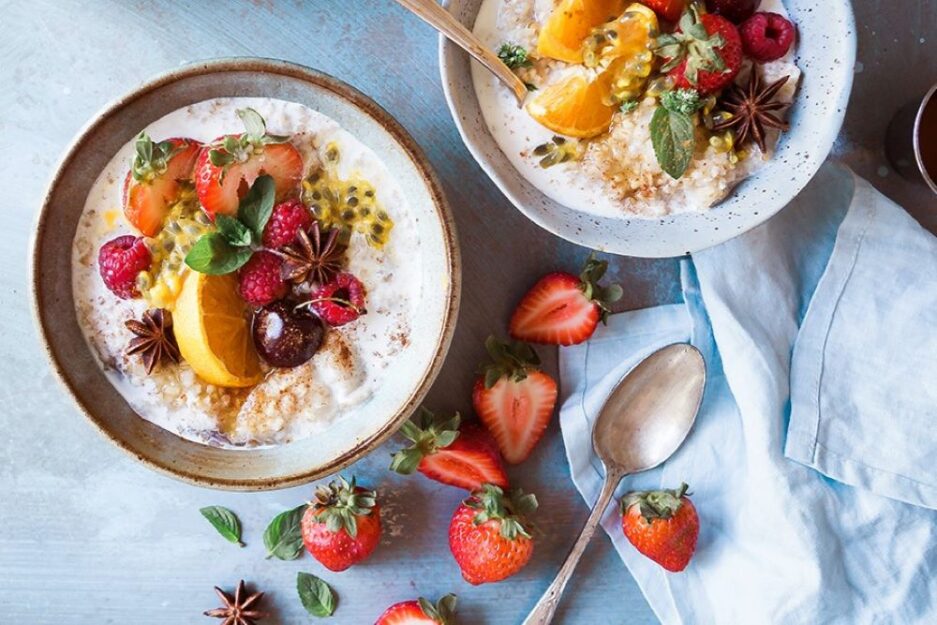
[472,0,800,217]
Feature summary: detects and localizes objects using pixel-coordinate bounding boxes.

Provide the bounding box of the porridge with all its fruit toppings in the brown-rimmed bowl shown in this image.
[72,98,422,447]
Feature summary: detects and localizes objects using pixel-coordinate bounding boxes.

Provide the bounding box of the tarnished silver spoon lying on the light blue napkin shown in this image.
[523,343,706,625]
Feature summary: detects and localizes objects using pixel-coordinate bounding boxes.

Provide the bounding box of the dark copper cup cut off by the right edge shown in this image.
[885,85,937,193]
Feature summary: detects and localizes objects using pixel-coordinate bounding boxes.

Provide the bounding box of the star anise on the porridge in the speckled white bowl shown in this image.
[713,67,790,154]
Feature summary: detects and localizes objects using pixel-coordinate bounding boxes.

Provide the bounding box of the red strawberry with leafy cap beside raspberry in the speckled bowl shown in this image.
[656,5,742,95]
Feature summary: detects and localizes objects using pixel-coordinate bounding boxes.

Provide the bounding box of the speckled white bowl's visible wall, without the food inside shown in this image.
[439,0,856,257]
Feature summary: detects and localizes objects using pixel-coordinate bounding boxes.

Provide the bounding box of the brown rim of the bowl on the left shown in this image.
[28,57,462,491]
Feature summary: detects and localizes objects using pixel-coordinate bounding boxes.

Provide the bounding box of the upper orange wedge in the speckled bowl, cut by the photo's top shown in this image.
[537,0,625,63]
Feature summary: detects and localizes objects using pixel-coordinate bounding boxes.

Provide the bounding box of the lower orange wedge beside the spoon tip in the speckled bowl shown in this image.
[527,76,615,139]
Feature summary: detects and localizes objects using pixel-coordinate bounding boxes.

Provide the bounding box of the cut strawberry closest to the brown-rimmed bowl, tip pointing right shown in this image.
[390,408,508,491]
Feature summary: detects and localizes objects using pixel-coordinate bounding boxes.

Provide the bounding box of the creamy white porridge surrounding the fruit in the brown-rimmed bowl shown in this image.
[72,98,422,447]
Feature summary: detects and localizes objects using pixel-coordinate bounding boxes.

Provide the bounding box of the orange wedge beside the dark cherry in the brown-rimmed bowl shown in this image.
[173,271,263,387]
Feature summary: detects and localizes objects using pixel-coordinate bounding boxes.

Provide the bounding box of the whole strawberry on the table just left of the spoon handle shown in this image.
[449,484,537,586]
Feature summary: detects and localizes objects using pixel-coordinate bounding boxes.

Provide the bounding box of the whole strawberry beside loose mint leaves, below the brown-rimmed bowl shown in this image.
[302,477,381,572]
